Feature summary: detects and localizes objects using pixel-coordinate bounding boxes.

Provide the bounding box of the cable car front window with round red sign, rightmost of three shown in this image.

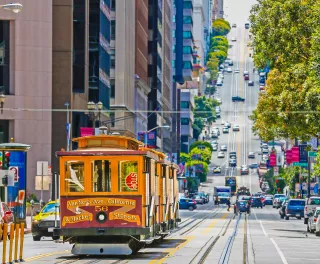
[119,161,139,192]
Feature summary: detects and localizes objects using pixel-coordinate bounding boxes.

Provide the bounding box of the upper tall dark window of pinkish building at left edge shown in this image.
[0,20,10,94]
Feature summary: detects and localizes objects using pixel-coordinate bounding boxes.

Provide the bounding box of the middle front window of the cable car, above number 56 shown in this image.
[91,160,111,192]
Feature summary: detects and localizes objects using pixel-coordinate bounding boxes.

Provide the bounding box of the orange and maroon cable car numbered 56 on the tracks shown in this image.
[54,135,180,255]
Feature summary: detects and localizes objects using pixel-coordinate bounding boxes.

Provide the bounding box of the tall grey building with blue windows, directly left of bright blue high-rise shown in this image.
[148,0,173,152]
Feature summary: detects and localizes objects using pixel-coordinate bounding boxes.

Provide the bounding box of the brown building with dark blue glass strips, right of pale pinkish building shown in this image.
[52,0,111,175]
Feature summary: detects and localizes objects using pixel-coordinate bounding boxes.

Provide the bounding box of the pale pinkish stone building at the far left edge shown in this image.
[0,0,52,199]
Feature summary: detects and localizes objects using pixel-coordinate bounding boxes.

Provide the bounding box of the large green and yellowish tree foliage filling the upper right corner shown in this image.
[250,0,320,140]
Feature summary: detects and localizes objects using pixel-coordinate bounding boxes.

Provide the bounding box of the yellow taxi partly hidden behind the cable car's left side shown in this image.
[31,201,60,241]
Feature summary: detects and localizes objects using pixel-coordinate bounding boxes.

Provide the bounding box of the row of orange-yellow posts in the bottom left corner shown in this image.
[0,222,24,264]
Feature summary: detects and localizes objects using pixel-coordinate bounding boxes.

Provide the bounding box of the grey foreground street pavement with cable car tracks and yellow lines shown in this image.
[1,204,320,264]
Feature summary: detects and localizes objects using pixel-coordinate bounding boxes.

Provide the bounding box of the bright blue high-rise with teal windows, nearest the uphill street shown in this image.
[172,0,194,156]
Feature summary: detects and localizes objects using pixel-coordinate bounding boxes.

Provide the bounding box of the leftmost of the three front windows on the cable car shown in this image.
[65,160,84,192]
